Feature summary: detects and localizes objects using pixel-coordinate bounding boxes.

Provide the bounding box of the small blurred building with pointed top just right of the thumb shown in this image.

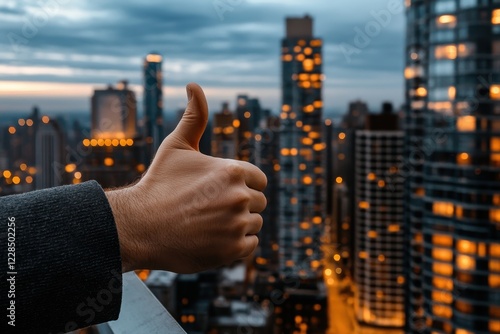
[212,103,240,159]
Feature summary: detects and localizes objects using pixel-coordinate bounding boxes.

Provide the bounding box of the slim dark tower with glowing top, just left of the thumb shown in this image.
[144,52,165,158]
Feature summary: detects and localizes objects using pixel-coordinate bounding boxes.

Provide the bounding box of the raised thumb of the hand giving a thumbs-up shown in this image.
[168,83,208,151]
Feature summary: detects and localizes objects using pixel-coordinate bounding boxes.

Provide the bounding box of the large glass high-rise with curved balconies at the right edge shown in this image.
[400,0,500,334]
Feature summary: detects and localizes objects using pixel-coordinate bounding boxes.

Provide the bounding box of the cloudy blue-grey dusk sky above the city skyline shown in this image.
[0,0,405,113]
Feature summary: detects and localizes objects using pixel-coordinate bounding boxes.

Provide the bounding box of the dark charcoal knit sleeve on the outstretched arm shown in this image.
[0,181,122,334]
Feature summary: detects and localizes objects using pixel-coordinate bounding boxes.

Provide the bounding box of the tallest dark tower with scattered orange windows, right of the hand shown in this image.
[279,16,325,280]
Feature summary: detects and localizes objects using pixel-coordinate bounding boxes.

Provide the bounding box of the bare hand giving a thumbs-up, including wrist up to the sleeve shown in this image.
[106,84,267,273]
